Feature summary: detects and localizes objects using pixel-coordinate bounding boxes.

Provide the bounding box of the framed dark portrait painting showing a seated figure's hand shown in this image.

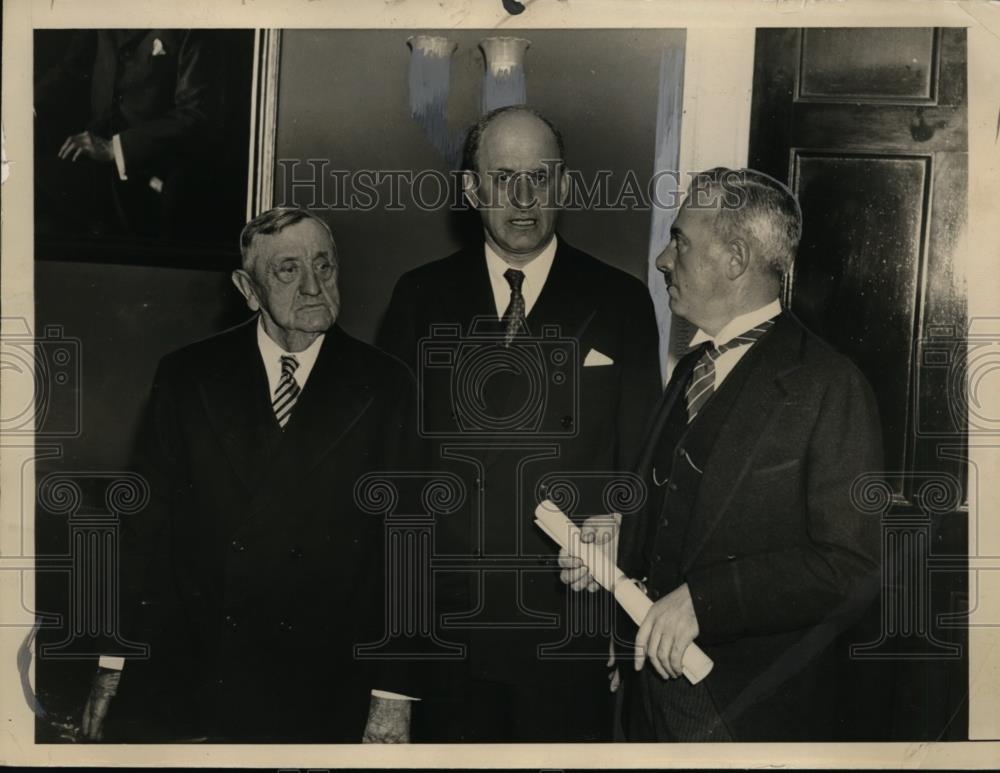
[33,29,277,268]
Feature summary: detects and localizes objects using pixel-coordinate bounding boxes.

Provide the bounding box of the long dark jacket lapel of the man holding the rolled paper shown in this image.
[682,315,802,571]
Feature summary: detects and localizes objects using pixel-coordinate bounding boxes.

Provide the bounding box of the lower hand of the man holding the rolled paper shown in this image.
[635,583,698,679]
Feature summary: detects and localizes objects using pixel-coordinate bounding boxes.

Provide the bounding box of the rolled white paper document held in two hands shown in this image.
[535,499,715,684]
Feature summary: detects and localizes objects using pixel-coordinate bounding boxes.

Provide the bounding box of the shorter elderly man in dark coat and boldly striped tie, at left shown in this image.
[83,209,415,742]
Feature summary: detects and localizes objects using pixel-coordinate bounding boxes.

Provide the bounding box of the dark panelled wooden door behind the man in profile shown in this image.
[749,28,968,739]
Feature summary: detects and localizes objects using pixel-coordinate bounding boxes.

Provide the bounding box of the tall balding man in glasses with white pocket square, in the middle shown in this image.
[378,106,660,742]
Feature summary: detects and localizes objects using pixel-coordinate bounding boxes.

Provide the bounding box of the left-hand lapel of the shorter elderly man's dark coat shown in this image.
[201,317,278,491]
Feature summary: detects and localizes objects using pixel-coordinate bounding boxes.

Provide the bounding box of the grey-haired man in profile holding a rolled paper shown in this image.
[561,169,882,741]
